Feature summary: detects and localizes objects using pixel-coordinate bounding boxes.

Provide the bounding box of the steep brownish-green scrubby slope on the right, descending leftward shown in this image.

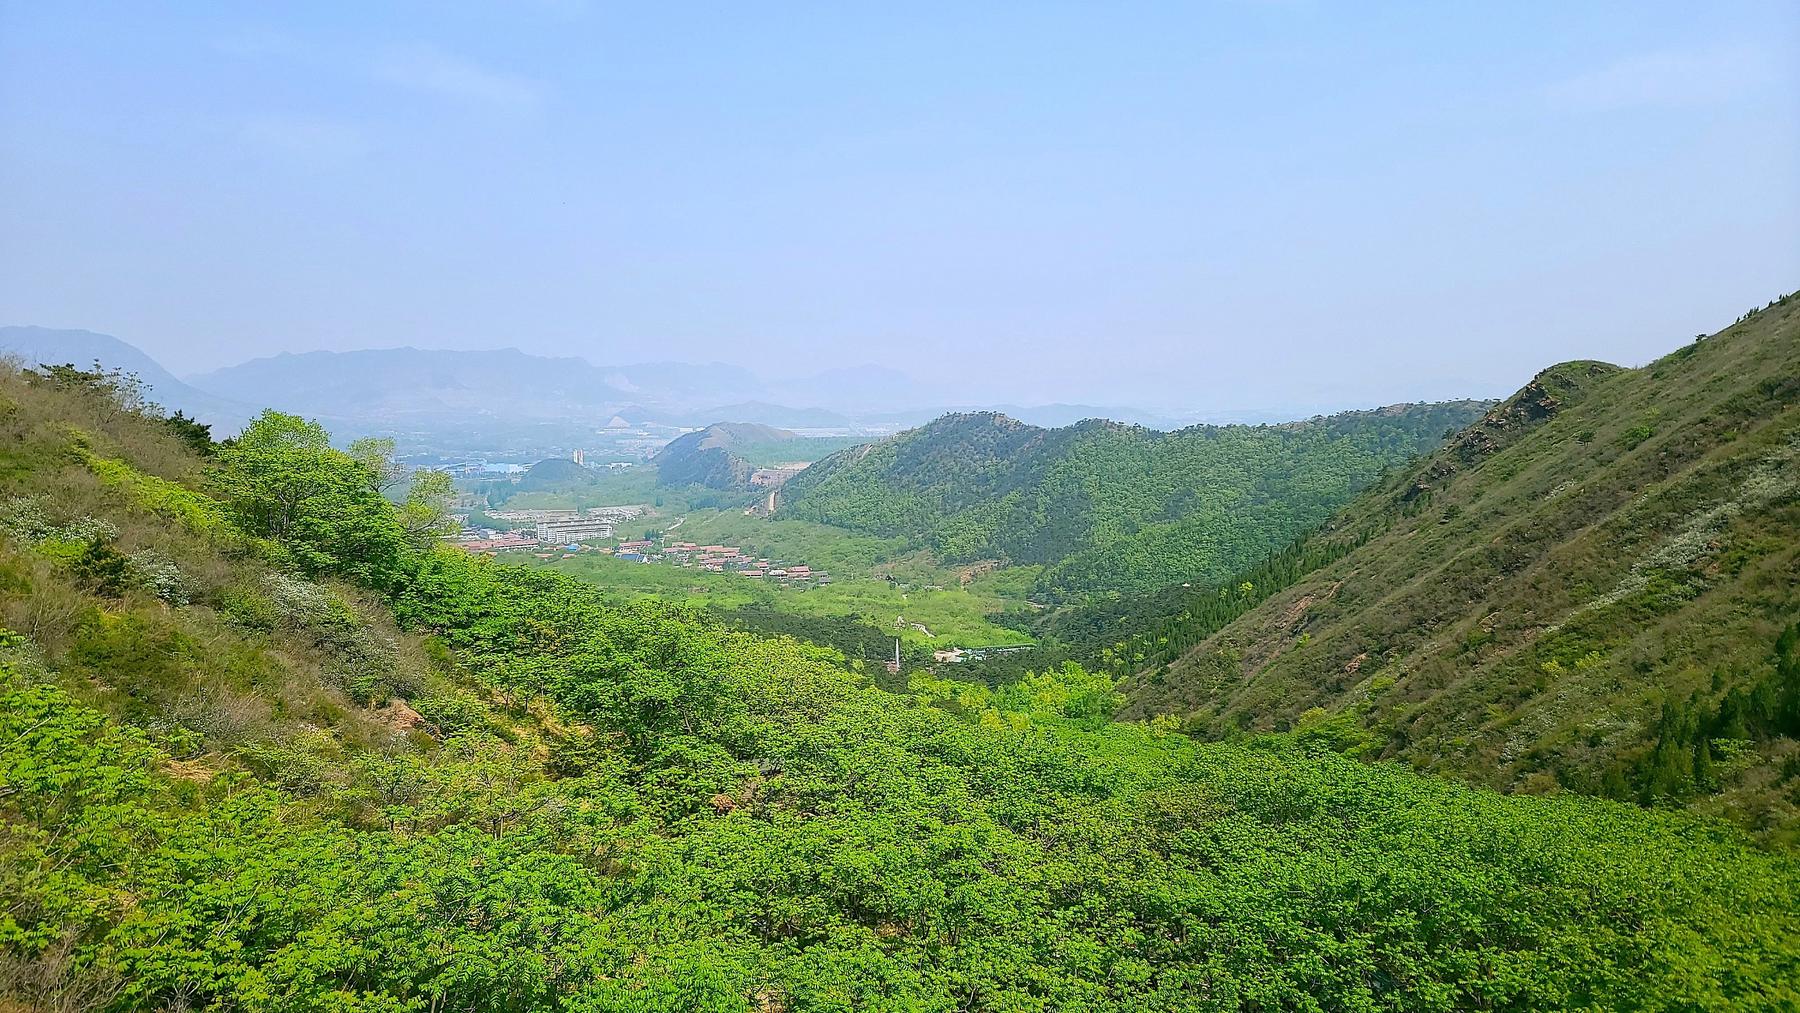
[1112,297,1800,838]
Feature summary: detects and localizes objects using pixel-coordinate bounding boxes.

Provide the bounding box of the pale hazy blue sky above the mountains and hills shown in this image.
[0,0,1800,408]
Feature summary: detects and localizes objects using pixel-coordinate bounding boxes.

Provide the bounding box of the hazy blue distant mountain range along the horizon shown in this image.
[0,327,1468,444]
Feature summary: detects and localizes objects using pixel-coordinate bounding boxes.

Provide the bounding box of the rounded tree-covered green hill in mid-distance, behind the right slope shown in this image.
[779,401,1487,597]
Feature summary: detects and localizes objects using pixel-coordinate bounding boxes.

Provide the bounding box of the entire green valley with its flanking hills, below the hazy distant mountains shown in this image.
[0,297,1800,1011]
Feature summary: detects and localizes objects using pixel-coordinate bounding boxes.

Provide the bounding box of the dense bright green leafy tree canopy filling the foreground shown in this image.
[0,579,1800,1009]
